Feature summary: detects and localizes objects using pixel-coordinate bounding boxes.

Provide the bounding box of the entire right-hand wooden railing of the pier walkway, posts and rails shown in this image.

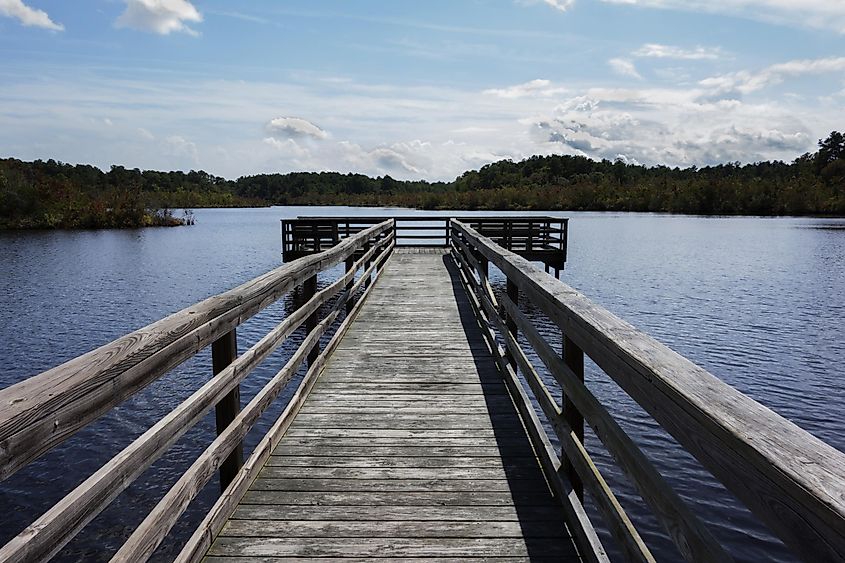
[450,220,845,561]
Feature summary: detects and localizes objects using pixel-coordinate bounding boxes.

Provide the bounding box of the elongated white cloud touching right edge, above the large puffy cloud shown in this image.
[700,57,845,95]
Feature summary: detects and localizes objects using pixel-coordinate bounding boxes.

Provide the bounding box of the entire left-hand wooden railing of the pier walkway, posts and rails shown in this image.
[0,219,395,562]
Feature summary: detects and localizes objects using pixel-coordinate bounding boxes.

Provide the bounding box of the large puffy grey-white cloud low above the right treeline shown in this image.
[532,90,813,166]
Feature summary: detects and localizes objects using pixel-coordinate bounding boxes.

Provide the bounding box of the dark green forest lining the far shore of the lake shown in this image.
[0,131,845,229]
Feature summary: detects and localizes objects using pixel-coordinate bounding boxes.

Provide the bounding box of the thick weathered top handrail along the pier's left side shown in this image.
[0,221,392,480]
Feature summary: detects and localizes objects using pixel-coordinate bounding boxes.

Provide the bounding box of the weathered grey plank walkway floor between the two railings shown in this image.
[207,249,578,562]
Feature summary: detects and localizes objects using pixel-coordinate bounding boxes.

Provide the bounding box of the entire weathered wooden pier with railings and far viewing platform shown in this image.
[0,217,845,563]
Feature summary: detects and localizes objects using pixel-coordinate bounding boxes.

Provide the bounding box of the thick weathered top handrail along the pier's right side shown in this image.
[452,221,845,561]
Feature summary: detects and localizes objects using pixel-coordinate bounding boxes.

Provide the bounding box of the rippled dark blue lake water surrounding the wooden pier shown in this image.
[0,208,845,561]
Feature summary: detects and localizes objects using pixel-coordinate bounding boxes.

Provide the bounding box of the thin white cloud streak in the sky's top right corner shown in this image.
[602,0,845,33]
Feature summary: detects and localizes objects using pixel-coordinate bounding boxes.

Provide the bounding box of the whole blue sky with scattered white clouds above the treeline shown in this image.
[0,0,845,180]
